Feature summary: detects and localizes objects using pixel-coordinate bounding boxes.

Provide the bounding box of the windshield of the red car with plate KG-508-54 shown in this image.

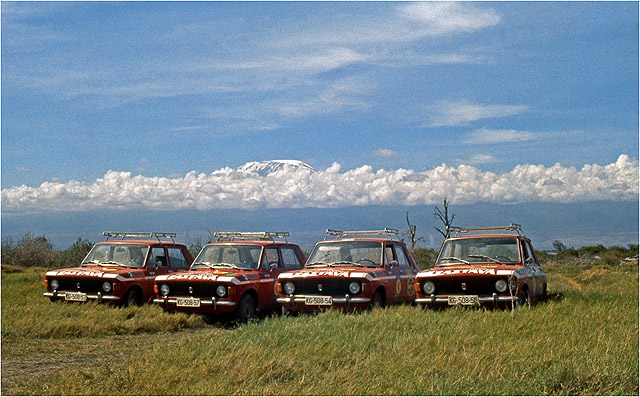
[305,241,382,267]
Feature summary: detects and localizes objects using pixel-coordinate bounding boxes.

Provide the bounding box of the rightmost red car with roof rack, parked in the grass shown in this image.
[415,224,547,308]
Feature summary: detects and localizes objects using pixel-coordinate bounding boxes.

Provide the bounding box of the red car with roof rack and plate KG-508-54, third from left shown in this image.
[276,229,418,312]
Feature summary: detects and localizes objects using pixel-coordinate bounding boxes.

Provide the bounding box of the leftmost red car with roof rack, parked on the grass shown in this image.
[44,232,193,306]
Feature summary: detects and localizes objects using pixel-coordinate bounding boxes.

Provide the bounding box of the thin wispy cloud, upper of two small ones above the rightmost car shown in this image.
[429,101,529,127]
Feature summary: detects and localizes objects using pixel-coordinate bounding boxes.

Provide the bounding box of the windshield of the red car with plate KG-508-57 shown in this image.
[191,244,262,270]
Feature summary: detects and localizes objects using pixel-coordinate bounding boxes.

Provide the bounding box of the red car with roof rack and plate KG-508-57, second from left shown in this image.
[154,232,304,323]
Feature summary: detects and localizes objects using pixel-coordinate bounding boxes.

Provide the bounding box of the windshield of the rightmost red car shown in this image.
[436,237,520,266]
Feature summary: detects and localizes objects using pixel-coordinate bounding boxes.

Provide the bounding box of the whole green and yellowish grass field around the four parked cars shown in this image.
[2,265,639,395]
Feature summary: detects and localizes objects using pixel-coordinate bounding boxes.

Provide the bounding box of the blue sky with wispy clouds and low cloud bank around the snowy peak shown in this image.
[1,2,639,251]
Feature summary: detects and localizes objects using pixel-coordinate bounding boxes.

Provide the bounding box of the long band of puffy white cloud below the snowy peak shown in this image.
[2,154,638,213]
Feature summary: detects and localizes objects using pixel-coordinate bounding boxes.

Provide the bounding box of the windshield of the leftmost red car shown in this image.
[82,243,149,268]
